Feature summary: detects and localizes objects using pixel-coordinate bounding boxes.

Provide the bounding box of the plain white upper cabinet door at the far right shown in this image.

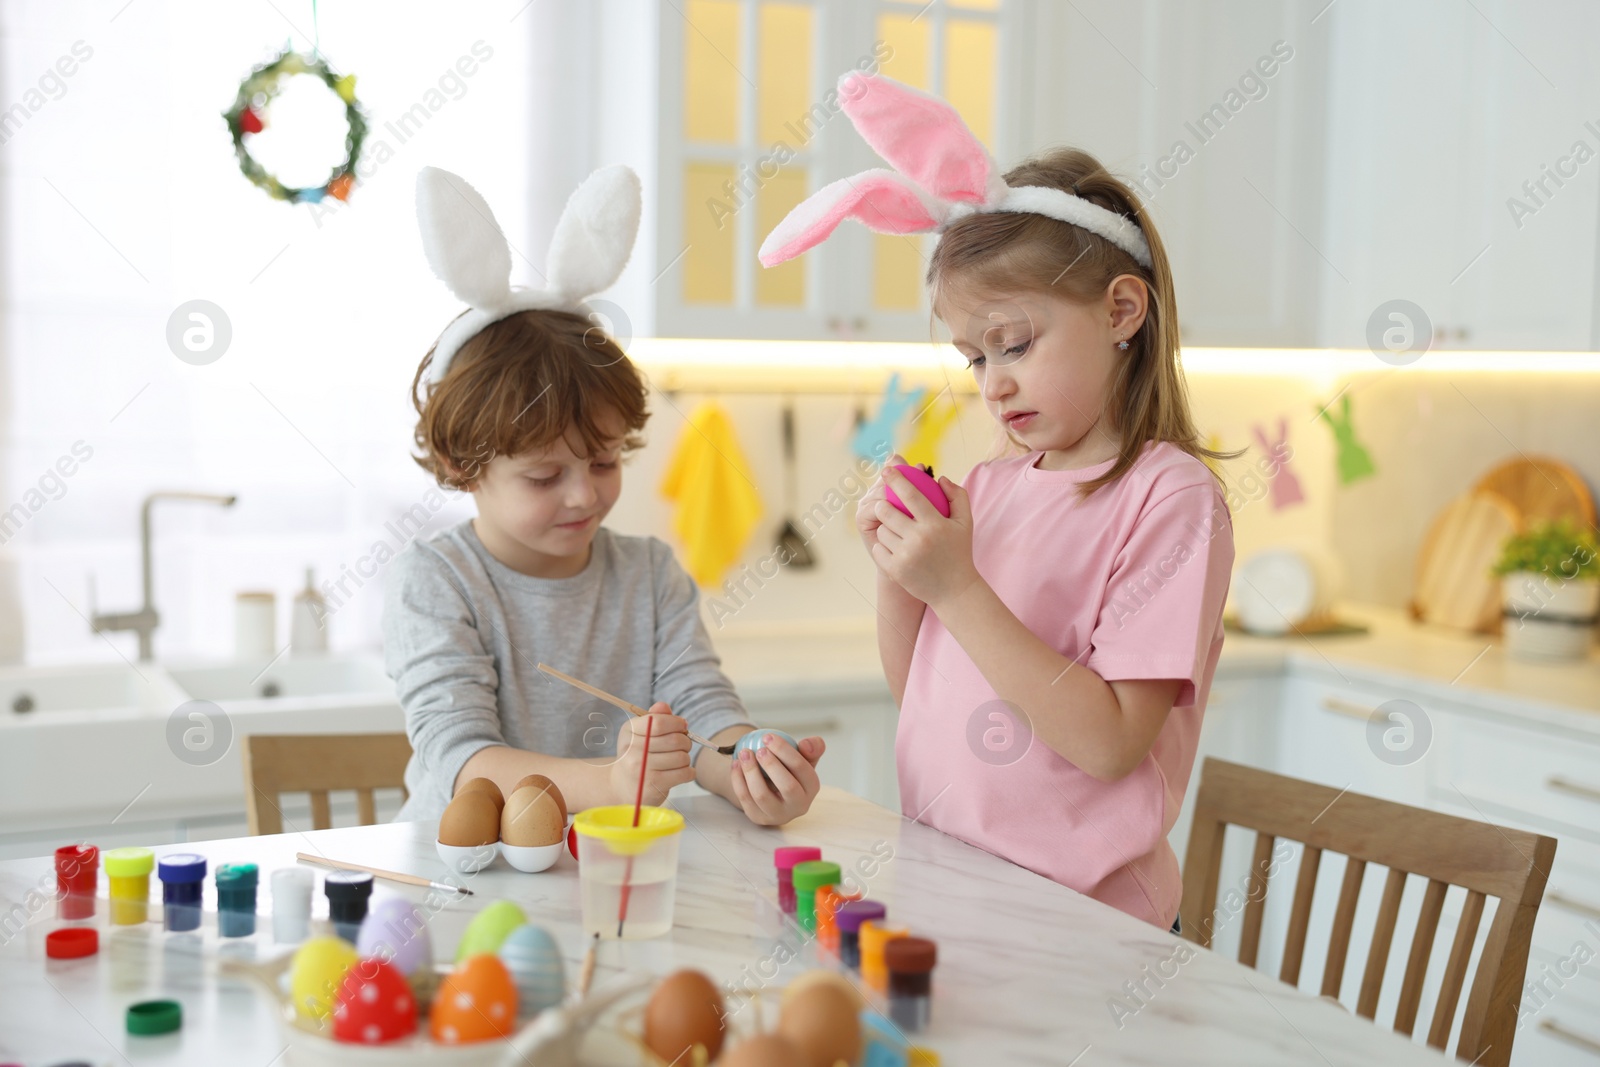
[1318,0,1600,350]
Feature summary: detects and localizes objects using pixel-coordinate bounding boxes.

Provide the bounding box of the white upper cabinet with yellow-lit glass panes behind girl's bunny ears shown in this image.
[653,0,1032,341]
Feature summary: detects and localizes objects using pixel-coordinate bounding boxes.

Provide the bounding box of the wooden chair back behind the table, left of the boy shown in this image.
[243,734,411,833]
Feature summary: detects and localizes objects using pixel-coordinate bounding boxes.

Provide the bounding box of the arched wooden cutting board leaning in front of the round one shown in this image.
[1411,490,1522,633]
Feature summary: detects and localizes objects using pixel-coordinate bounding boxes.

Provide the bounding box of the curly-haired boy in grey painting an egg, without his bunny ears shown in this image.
[384,309,824,825]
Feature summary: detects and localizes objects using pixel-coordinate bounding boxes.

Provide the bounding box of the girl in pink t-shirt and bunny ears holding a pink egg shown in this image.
[763,75,1234,929]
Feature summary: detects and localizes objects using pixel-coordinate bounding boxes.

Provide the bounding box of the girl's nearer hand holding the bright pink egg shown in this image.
[870,469,982,613]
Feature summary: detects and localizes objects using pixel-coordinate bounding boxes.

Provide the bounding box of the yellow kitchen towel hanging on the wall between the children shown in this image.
[661,400,762,585]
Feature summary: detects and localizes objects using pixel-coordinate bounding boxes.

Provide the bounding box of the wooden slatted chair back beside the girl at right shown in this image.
[1179,758,1555,1067]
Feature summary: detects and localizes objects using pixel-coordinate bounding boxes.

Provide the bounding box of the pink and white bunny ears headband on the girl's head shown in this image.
[758,72,1150,269]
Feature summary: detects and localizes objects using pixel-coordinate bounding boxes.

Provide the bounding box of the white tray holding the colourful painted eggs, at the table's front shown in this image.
[222,953,652,1067]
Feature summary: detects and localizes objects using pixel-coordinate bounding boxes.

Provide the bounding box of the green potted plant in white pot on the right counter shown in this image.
[1494,518,1600,659]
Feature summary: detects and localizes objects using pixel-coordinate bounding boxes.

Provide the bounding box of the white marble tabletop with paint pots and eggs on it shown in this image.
[0,790,1446,1067]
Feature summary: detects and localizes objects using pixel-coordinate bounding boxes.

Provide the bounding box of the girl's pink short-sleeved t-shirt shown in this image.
[894,442,1234,928]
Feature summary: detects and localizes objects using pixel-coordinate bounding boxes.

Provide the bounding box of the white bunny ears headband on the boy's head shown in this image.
[416,165,642,382]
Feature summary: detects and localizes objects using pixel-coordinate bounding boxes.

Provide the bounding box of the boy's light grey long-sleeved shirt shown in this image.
[384,520,749,822]
